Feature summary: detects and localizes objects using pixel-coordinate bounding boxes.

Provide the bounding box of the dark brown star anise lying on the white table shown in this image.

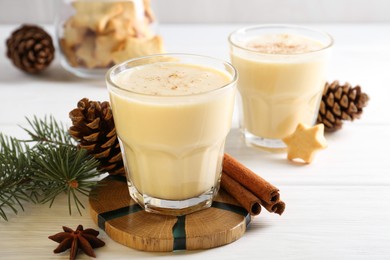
[49,225,105,260]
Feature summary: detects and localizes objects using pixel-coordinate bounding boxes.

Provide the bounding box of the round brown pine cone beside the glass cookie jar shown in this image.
[6,25,54,73]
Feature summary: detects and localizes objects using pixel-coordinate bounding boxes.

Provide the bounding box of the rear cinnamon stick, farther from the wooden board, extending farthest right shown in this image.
[222,153,286,215]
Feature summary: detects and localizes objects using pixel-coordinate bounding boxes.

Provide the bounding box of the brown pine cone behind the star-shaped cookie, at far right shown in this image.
[317,80,369,132]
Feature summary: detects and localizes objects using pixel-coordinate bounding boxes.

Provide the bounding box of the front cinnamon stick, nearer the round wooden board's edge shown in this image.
[221,172,261,215]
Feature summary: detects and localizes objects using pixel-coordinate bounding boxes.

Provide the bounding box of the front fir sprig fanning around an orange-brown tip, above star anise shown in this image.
[32,144,100,215]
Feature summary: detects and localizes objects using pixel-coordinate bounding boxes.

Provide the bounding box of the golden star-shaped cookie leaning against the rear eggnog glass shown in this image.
[283,123,327,163]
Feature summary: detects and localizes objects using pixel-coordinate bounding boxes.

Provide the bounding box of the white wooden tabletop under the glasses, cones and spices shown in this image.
[0,24,390,259]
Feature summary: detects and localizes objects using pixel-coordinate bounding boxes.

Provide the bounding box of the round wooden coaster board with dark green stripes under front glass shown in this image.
[89,176,251,252]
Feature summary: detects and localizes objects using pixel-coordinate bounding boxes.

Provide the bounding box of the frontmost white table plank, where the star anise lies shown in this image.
[0,185,390,259]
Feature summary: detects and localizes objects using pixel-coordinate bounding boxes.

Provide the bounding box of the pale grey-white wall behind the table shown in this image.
[0,0,390,24]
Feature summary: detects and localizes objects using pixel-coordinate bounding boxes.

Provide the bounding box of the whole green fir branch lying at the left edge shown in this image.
[0,116,101,220]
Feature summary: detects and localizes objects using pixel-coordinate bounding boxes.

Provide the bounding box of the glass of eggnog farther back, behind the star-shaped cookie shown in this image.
[229,25,333,148]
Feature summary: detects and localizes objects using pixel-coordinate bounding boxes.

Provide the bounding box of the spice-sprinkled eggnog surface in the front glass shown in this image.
[115,62,231,96]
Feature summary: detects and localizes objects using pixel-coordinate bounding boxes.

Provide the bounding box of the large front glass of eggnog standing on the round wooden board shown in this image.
[106,54,237,215]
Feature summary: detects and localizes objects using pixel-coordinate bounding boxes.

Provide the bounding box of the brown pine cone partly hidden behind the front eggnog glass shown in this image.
[69,98,125,175]
